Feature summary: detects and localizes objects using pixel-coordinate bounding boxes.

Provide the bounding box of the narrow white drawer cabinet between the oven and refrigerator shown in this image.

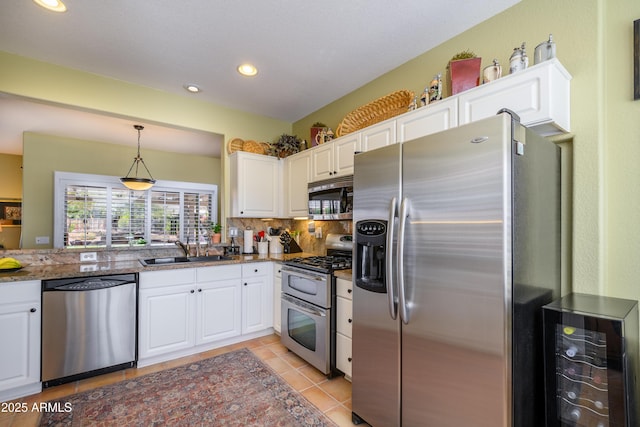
[336,278,353,379]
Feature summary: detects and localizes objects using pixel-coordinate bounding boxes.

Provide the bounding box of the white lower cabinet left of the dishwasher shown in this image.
[0,280,42,402]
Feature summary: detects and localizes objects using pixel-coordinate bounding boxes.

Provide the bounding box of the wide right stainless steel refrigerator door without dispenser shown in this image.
[402,114,511,427]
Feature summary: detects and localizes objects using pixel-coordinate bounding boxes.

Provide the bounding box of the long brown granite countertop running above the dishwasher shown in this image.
[0,252,314,285]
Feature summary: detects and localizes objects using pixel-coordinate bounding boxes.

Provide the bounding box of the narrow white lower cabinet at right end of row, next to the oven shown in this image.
[242,262,273,334]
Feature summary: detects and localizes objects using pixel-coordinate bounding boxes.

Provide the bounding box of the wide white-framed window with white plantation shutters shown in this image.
[54,172,218,248]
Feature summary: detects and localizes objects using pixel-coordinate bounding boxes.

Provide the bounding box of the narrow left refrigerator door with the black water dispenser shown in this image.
[352,144,401,426]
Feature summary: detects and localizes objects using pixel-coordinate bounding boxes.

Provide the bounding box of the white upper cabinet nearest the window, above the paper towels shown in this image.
[229,151,282,218]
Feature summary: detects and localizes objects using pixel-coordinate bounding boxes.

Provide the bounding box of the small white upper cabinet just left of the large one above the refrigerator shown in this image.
[396,97,458,142]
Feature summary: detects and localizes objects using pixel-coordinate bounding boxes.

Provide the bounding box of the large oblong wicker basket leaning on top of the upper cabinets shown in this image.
[336,90,413,136]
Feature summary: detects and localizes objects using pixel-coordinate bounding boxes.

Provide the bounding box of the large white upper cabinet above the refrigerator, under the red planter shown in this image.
[458,58,571,136]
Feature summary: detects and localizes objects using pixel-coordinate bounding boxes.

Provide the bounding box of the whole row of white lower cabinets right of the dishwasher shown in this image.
[138,262,273,366]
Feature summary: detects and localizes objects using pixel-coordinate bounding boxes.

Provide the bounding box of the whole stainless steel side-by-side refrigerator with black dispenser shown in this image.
[352,112,561,427]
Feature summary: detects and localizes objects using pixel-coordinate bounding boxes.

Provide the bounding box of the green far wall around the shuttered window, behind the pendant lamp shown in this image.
[22,132,222,249]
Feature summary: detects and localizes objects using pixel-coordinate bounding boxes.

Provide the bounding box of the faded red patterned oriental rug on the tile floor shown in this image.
[40,348,336,427]
